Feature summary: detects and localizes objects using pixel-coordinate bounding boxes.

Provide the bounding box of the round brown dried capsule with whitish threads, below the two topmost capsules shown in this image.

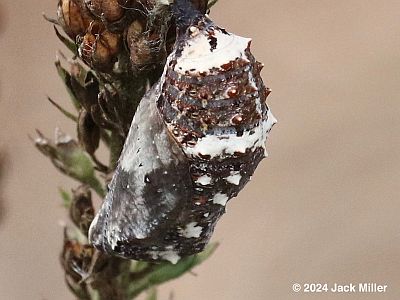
[78,22,121,71]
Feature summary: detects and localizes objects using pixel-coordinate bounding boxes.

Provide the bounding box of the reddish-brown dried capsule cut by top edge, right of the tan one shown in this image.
[85,0,124,22]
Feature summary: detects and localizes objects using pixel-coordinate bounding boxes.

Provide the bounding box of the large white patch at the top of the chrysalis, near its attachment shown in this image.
[175,28,251,74]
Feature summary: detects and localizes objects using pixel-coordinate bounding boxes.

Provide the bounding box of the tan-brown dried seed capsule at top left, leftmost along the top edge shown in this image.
[57,0,93,40]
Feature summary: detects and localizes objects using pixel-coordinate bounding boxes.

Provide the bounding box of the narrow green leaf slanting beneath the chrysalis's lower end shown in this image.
[127,243,218,299]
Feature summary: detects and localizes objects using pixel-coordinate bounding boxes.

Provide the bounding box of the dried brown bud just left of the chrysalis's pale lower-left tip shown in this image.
[70,185,94,236]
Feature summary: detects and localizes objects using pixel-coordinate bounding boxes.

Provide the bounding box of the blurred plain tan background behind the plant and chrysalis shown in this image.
[0,0,400,300]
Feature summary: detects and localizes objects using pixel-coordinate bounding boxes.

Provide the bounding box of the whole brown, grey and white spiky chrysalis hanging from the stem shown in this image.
[89,0,276,263]
